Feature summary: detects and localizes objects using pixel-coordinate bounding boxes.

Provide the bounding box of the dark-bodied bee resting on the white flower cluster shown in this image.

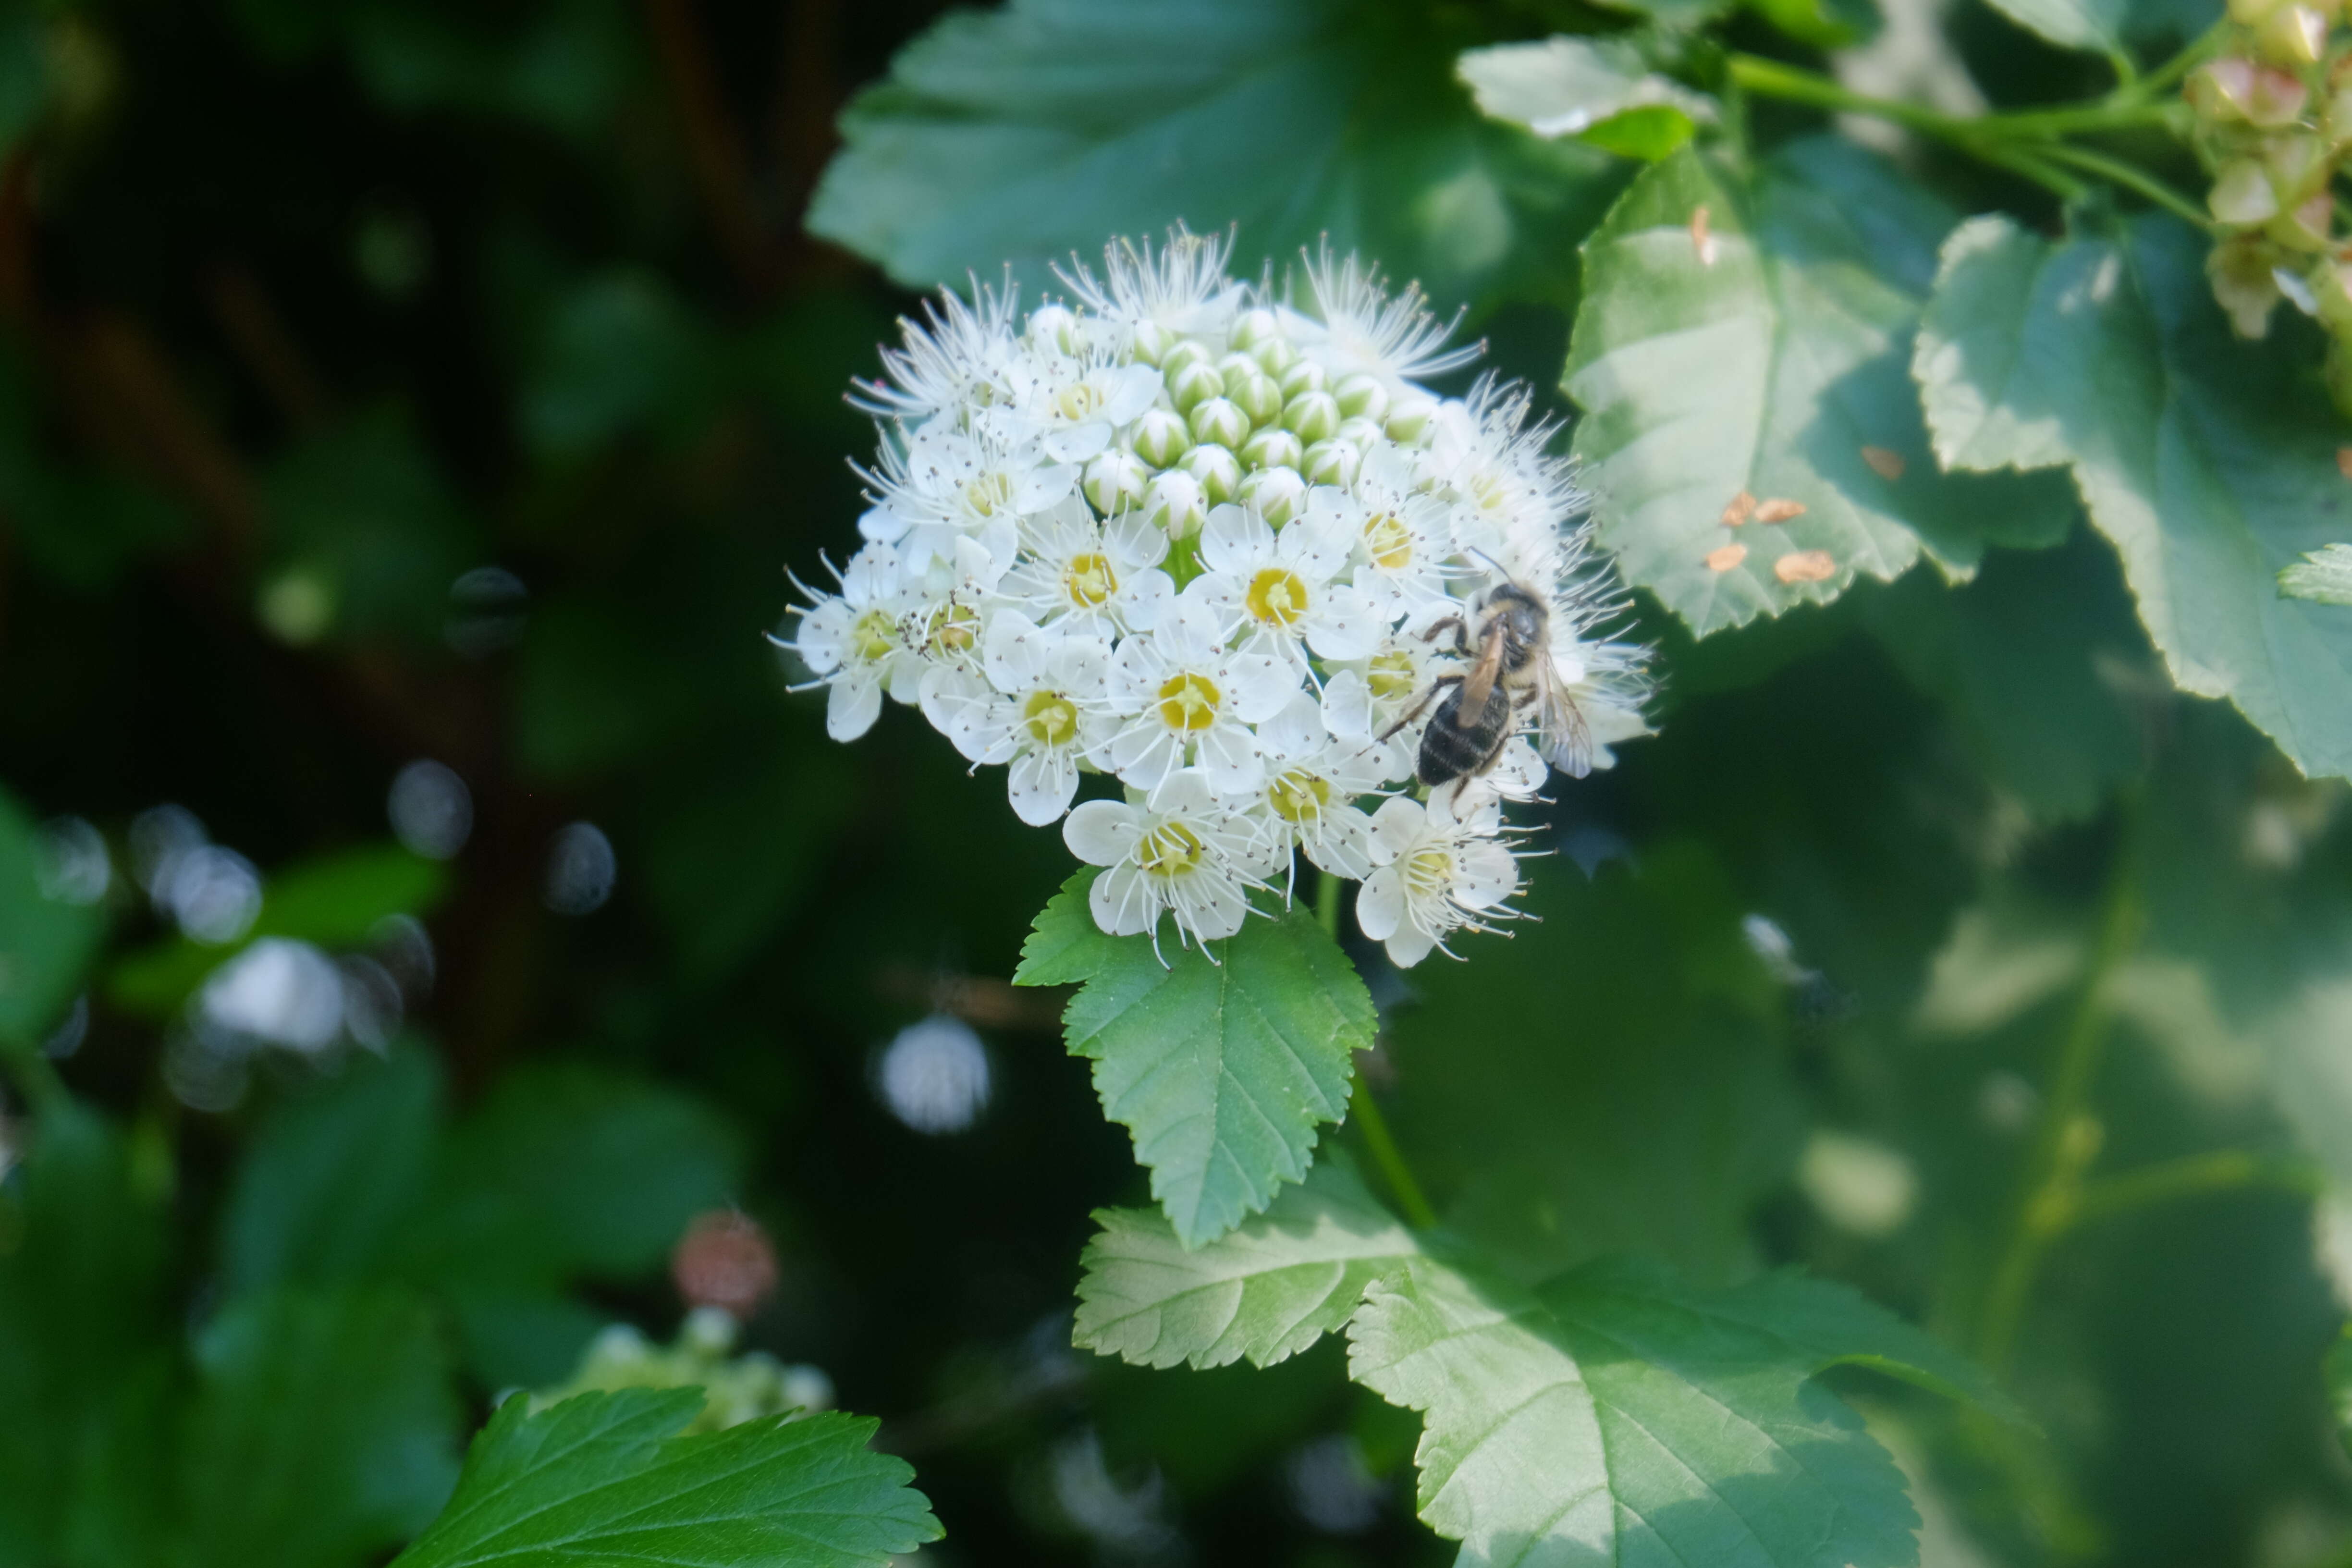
[1381,578,1592,795]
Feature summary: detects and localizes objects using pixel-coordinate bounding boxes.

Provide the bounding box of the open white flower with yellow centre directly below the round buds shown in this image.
[1183,505,1388,668]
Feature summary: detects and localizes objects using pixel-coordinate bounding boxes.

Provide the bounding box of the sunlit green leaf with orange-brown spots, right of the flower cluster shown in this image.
[1562,139,2068,635]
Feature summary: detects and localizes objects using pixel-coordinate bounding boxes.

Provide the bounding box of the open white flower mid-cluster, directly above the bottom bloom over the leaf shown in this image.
[1098,609,1298,795]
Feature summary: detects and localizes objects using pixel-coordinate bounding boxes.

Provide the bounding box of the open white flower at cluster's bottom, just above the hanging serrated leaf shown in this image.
[1061,769,1275,945]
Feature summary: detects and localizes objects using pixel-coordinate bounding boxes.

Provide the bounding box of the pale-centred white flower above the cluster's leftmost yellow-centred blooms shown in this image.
[858,418,1077,578]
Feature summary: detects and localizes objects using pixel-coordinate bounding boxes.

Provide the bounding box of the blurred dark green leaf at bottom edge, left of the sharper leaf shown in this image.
[176,1288,459,1568]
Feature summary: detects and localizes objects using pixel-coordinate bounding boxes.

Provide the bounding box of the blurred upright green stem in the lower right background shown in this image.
[1978,822,2140,1373]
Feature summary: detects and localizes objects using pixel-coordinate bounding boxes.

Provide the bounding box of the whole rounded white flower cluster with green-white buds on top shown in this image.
[790,231,1644,964]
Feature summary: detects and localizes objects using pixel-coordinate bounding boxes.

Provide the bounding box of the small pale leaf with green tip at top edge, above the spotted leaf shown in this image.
[1454,35,1717,160]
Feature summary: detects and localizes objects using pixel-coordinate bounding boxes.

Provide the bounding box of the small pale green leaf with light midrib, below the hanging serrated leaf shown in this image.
[1070,1152,1421,1368]
